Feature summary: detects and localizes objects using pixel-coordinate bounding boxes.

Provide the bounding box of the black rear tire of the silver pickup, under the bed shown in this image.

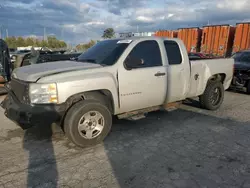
[200,81,224,110]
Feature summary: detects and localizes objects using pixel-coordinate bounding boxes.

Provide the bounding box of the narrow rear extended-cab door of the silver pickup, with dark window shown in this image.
[164,40,190,102]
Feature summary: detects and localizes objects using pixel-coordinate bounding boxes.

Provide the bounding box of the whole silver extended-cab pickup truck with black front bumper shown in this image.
[1,37,234,147]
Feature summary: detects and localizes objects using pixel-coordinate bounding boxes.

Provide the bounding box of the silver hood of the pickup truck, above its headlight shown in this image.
[12,61,101,82]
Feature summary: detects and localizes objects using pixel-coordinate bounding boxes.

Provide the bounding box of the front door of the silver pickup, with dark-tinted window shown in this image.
[118,40,167,113]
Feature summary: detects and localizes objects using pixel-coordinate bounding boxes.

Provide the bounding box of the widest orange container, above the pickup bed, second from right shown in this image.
[201,25,235,57]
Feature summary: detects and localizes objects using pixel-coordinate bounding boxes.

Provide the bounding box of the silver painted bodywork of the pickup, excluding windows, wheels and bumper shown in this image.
[10,37,233,115]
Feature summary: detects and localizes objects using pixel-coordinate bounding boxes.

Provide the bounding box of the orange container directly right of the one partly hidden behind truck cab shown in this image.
[178,27,201,52]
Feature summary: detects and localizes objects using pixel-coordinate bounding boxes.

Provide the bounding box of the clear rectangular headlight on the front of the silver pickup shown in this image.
[29,83,58,104]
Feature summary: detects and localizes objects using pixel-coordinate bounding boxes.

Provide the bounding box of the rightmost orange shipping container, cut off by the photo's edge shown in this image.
[233,23,250,52]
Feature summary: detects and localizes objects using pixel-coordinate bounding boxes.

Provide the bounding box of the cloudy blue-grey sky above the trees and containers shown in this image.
[0,0,250,44]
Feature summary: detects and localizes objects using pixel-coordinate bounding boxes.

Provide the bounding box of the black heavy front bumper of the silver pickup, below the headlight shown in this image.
[1,91,66,129]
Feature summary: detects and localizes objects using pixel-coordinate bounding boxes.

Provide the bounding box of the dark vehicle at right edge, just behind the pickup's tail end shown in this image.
[231,50,250,94]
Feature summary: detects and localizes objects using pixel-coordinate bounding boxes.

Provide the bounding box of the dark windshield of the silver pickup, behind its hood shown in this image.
[77,39,129,65]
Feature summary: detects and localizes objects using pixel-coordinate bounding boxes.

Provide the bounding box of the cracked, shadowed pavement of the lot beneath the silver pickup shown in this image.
[0,92,250,188]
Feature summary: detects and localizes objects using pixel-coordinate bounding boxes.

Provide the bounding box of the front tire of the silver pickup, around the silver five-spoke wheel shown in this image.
[64,100,112,147]
